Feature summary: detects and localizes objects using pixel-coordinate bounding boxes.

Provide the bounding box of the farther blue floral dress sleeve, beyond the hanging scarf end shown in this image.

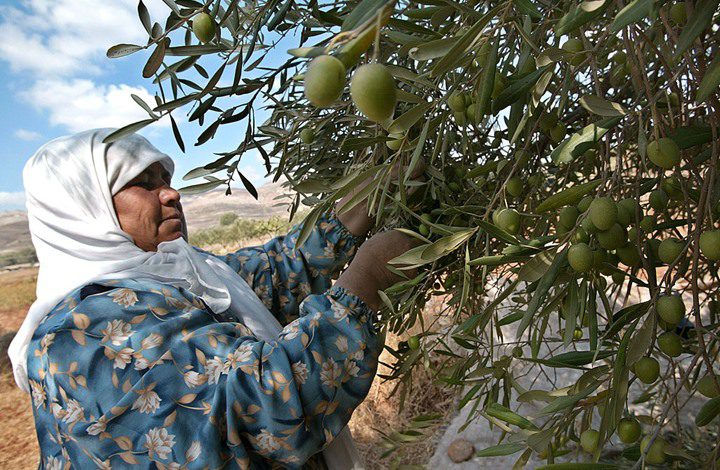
[201,207,364,325]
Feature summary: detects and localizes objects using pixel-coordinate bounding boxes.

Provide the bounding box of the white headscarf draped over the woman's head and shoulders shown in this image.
[8,128,362,470]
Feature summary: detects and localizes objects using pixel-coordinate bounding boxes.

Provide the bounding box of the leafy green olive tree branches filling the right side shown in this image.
[108,0,720,468]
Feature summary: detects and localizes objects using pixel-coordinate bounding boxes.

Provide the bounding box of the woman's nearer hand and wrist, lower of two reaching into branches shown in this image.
[335,230,422,311]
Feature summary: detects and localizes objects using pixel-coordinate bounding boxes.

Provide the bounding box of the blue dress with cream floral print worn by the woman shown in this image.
[28,211,383,470]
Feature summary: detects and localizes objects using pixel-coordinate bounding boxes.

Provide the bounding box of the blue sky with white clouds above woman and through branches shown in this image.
[0,0,298,211]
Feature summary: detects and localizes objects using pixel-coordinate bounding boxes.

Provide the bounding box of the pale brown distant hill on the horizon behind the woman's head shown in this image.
[0,180,293,255]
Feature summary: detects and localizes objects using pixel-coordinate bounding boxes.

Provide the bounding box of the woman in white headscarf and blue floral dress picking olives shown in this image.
[9,129,414,469]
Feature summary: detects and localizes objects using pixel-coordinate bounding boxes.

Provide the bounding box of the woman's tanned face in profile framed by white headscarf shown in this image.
[113,162,187,251]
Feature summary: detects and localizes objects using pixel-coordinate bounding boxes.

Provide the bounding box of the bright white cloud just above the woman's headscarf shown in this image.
[21,79,169,132]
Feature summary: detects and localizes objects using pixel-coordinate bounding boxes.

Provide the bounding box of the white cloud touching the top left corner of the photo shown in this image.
[0,0,169,76]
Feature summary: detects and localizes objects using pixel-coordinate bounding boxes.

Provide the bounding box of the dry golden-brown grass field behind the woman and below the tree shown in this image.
[0,228,453,469]
